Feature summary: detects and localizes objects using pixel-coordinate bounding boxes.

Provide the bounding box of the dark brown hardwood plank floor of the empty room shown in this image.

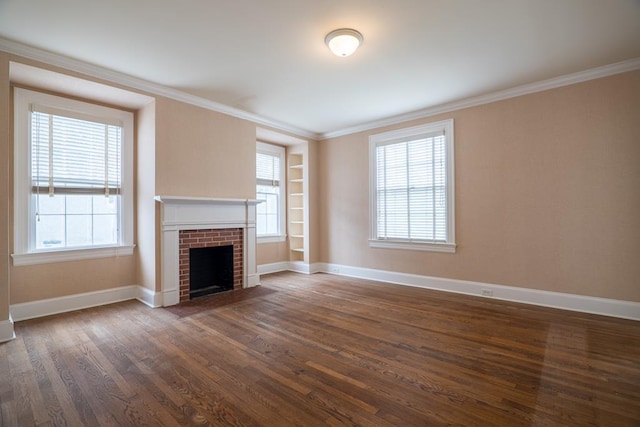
[0,273,640,427]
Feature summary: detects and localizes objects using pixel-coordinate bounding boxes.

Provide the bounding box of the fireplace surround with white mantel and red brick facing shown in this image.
[155,196,260,307]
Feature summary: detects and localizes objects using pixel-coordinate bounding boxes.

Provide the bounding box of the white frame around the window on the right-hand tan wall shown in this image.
[369,119,456,253]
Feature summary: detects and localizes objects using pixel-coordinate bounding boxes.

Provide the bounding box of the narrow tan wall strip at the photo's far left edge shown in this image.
[0,52,11,322]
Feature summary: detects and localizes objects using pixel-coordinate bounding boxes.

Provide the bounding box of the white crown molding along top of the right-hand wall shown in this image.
[318,58,640,141]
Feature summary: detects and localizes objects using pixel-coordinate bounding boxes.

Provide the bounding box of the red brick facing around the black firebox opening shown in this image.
[179,228,244,302]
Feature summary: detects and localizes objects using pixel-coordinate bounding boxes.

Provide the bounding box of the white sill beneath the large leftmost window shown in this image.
[11,245,135,266]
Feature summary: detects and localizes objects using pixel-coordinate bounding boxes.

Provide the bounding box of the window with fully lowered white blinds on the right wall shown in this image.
[369,120,455,252]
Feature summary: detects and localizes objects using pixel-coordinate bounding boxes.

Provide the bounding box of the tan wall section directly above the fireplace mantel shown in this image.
[156,98,256,199]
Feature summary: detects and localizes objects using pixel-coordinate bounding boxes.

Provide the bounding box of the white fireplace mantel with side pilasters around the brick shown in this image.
[155,196,262,307]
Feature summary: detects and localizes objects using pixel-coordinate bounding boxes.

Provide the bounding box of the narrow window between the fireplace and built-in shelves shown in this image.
[256,142,286,243]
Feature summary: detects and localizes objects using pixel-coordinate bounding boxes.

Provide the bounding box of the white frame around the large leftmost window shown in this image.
[11,88,134,266]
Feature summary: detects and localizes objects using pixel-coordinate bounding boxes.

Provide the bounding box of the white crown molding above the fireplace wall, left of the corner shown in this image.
[0,37,320,139]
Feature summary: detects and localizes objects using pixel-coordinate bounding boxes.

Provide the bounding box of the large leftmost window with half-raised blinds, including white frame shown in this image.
[14,88,133,265]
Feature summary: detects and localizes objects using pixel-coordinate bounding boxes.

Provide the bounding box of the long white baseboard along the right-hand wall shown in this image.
[317,263,640,320]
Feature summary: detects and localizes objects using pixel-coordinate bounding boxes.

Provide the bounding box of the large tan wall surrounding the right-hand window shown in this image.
[319,71,640,302]
